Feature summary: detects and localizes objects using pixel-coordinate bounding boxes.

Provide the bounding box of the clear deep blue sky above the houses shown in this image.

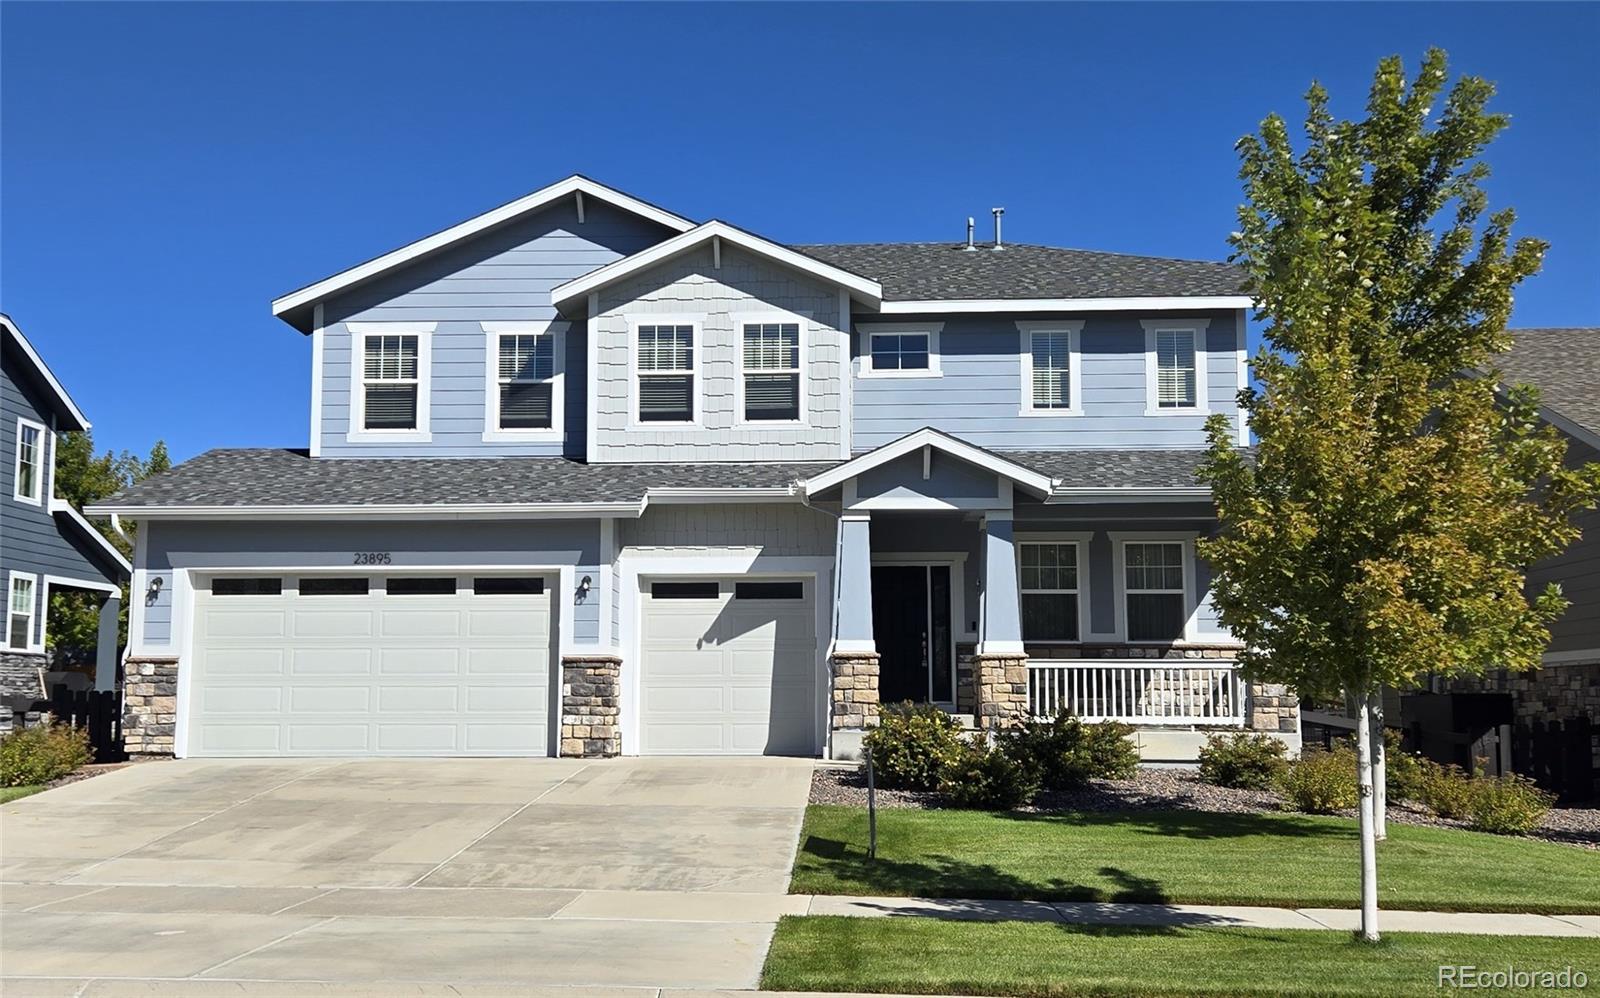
[0,2,1600,459]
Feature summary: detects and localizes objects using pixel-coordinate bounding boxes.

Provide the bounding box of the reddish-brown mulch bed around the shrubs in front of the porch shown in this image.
[811,766,1600,849]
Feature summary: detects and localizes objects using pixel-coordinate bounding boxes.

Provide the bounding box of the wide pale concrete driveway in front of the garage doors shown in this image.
[0,760,811,995]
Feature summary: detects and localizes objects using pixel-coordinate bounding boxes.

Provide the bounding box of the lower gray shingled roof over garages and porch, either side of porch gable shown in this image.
[96,449,1200,509]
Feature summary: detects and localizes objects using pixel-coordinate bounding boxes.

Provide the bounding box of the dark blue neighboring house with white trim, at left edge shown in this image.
[0,315,131,728]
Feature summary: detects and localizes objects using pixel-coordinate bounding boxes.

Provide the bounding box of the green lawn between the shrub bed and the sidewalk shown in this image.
[789,804,1600,913]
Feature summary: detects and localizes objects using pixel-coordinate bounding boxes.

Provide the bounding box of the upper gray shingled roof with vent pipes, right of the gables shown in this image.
[794,243,1243,301]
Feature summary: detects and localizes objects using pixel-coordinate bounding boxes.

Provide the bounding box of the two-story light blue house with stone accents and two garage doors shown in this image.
[94,176,1299,761]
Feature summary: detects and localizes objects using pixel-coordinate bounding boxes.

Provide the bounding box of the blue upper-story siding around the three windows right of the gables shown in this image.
[851,312,1240,453]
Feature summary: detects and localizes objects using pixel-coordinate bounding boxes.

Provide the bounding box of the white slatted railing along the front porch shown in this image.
[1027,659,1245,726]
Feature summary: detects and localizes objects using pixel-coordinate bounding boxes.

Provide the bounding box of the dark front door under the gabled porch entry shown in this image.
[872,565,954,704]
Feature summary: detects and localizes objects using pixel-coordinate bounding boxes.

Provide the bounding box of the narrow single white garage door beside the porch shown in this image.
[640,579,819,755]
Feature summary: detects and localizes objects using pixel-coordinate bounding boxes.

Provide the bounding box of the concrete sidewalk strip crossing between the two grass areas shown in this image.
[805,894,1600,939]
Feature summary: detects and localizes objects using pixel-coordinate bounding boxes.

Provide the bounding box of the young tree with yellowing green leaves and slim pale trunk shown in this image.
[1200,50,1600,940]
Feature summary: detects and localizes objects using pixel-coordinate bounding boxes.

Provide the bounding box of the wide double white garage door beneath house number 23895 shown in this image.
[189,576,550,756]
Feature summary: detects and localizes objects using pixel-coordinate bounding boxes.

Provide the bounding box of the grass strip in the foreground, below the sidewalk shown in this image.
[762,916,1600,998]
